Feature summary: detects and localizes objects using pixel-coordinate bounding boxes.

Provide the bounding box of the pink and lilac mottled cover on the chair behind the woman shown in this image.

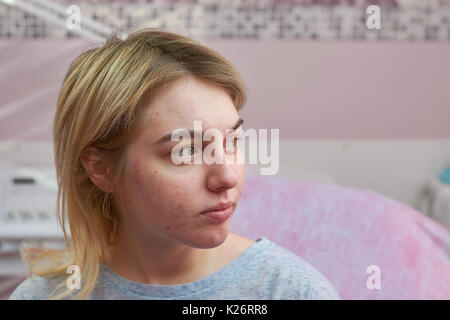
[230,173,450,299]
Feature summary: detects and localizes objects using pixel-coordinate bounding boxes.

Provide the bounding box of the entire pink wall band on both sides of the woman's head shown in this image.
[0,40,450,139]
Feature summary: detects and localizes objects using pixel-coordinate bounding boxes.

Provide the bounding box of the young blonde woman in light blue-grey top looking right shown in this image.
[10,29,339,299]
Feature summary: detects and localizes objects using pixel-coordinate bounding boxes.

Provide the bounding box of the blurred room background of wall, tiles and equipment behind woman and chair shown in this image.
[0,0,450,297]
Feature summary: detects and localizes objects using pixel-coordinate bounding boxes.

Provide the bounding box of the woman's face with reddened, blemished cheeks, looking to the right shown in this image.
[114,77,245,248]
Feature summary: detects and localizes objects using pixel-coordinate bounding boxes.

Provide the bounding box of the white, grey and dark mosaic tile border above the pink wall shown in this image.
[0,0,450,41]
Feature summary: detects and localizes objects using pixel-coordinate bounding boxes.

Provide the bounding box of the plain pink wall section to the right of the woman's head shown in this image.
[210,41,450,139]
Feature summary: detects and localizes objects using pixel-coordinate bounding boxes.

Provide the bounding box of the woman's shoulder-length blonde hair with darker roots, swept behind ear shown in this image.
[23,28,246,299]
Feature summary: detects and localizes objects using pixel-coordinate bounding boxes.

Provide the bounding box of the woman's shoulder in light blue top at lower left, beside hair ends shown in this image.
[9,274,64,300]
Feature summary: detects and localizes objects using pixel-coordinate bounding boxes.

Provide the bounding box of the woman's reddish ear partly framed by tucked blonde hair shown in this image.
[80,146,112,192]
